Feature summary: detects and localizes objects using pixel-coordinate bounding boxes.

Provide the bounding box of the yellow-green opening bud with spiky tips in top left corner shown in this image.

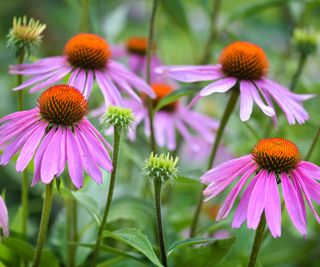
[8,16,46,56]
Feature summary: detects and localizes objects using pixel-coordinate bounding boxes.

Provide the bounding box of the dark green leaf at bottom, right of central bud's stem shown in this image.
[170,237,235,267]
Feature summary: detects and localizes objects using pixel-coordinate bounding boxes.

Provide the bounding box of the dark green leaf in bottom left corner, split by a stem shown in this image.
[2,237,59,267]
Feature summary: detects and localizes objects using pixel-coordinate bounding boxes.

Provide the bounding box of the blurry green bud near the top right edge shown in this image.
[293,28,320,56]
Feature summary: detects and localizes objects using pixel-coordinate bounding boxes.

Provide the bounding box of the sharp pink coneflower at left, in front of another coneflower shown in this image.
[0,85,112,188]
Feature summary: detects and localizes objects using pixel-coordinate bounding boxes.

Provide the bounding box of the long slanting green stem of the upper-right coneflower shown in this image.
[190,87,239,237]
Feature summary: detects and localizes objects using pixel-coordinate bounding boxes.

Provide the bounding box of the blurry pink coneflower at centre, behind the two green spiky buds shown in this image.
[127,83,218,150]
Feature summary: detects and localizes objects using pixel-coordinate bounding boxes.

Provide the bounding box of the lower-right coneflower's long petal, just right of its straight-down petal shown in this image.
[281,172,307,235]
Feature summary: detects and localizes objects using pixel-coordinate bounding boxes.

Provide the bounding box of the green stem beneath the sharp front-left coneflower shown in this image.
[32,182,53,267]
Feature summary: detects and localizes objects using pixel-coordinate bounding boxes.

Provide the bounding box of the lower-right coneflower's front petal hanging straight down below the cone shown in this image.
[265,172,281,238]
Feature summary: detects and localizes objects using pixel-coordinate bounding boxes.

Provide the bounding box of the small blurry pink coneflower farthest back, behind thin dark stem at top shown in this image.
[112,37,161,82]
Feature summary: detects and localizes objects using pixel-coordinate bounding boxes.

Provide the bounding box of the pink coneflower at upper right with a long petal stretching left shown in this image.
[156,42,313,124]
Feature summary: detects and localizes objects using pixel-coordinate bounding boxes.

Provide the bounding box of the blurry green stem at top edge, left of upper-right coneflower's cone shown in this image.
[199,0,221,65]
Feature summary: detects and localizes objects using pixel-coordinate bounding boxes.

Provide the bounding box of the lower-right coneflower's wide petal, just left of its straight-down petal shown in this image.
[247,170,268,229]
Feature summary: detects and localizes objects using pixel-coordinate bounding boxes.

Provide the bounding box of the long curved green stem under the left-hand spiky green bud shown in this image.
[92,126,122,267]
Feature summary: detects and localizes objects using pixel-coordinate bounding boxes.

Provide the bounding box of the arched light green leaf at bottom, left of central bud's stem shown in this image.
[103,228,163,267]
